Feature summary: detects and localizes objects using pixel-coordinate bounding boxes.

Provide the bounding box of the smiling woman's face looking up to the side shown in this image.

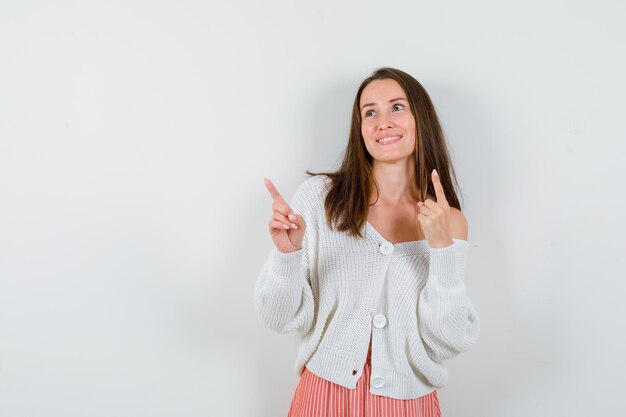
[359,79,415,162]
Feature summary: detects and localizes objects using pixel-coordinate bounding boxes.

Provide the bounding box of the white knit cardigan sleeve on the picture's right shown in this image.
[418,239,480,362]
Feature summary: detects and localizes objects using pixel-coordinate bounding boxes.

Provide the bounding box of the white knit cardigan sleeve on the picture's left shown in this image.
[254,180,316,334]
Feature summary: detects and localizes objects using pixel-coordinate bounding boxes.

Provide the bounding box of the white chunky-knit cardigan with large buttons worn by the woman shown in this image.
[254,175,480,399]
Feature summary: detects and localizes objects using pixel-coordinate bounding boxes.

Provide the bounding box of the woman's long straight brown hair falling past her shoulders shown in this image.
[306,67,461,237]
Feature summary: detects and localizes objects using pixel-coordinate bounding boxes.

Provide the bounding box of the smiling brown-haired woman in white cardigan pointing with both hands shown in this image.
[255,68,480,417]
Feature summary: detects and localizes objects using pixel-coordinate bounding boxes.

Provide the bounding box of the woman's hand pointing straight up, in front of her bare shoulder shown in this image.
[417,169,454,248]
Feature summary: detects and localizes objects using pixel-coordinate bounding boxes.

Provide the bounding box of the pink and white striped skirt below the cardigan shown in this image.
[287,351,441,417]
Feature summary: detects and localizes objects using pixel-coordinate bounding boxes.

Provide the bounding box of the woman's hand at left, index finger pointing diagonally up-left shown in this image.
[265,178,306,253]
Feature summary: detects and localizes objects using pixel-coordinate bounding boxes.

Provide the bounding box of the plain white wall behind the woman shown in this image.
[0,0,626,417]
